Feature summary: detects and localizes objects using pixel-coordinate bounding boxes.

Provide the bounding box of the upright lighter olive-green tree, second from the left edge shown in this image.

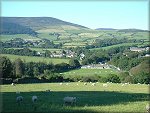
[15,58,24,77]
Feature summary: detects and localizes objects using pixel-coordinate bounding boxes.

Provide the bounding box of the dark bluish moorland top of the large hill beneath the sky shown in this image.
[1,17,87,30]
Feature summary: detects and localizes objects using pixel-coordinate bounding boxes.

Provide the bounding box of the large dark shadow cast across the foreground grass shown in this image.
[2,91,149,113]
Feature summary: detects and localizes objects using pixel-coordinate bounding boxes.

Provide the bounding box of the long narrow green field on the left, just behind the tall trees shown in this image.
[1,54,69,64]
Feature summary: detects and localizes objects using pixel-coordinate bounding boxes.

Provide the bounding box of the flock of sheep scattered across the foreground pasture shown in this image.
[11,82,150,113]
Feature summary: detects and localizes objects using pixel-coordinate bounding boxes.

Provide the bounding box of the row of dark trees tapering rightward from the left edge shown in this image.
[0,56,80,78]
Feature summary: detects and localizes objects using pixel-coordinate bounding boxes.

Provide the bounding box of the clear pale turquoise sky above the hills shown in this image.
[1,0,149,30]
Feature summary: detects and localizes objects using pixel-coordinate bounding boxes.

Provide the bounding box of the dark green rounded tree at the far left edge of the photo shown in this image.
[0,57,12,78]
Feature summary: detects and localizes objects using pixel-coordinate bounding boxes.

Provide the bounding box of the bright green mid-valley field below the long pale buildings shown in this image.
[63,69,119,77]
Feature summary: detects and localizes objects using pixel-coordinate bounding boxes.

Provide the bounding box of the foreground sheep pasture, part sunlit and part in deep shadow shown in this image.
[1,82,149,113]
